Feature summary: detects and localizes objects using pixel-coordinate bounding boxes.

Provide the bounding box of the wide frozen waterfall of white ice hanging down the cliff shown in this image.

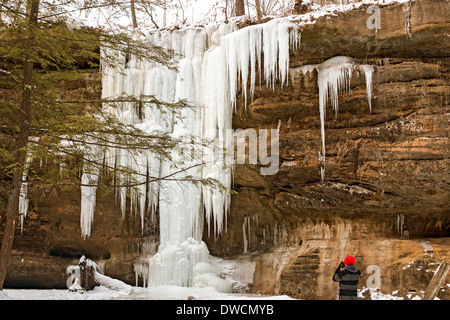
[94,19,299,291]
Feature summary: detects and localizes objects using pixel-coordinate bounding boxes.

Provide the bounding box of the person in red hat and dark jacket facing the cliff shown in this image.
[333,256,361,300]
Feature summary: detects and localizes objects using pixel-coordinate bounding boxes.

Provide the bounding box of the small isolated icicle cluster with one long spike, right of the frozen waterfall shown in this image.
[300,56,373,181]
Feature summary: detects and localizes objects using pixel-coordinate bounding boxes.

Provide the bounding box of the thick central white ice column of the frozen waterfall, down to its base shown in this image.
[144,25,236,291]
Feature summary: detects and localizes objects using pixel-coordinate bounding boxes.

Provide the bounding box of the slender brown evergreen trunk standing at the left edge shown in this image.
[0,0,39,290]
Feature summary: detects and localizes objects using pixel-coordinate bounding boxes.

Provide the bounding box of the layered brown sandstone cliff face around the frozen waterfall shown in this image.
[0,0,450,299]
